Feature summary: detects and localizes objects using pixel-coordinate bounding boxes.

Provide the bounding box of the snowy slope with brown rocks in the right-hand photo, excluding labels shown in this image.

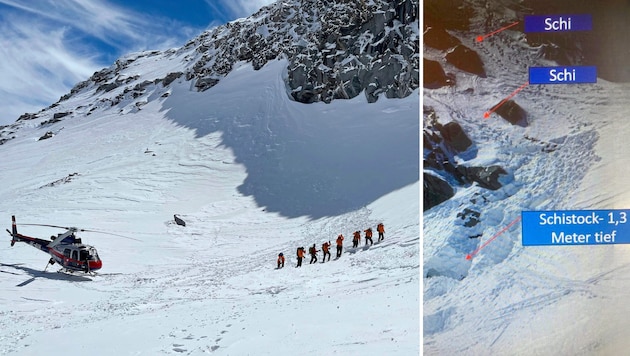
[423,1,630,355]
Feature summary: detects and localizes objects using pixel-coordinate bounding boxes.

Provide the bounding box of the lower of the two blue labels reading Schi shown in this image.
[529,66,597,84]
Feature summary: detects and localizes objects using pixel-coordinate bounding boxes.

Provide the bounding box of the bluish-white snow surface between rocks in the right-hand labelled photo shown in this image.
[423,6,630,355]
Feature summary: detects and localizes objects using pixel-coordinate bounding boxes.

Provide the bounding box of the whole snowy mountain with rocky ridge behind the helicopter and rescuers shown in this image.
[0,0,421,356]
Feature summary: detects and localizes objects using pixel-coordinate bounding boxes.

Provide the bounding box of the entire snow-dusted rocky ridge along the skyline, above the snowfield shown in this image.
[0,0,420,144]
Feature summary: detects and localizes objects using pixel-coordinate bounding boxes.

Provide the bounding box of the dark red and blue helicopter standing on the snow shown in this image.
[7,215,103,275]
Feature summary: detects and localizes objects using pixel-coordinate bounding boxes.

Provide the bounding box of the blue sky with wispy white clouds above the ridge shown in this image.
[0,0,275,125]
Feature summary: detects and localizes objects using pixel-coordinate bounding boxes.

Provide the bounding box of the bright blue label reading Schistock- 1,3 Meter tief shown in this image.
[521,210,630,246]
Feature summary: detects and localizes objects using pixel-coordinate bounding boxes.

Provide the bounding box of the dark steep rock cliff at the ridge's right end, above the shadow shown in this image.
[287,0,420,103]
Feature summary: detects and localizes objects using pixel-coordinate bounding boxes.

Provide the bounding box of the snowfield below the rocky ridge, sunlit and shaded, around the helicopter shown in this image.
[0,61,420,355]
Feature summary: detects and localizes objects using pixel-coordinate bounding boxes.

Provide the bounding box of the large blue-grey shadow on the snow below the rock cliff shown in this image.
[162,62,420,219]
